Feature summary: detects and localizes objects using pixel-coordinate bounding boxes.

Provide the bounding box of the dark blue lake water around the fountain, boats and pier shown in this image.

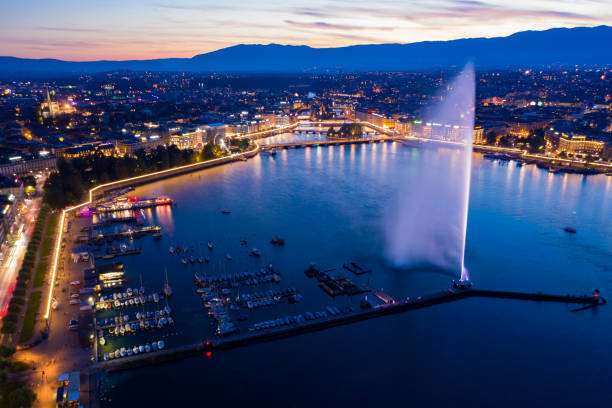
[102,139,612,407]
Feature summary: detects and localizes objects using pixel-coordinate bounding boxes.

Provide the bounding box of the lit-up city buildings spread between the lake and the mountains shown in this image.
[0,69,612,175]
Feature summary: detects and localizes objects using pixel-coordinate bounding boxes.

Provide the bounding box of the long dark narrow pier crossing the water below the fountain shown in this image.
[96,289,606,371]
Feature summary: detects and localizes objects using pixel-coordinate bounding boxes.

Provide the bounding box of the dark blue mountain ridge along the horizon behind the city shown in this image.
[0,26,612,76]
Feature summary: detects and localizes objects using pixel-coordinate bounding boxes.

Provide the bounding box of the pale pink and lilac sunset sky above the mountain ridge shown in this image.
[0,0,612,61]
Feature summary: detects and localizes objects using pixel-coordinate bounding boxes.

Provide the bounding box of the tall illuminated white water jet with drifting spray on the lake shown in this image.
[386,64,475,281]
